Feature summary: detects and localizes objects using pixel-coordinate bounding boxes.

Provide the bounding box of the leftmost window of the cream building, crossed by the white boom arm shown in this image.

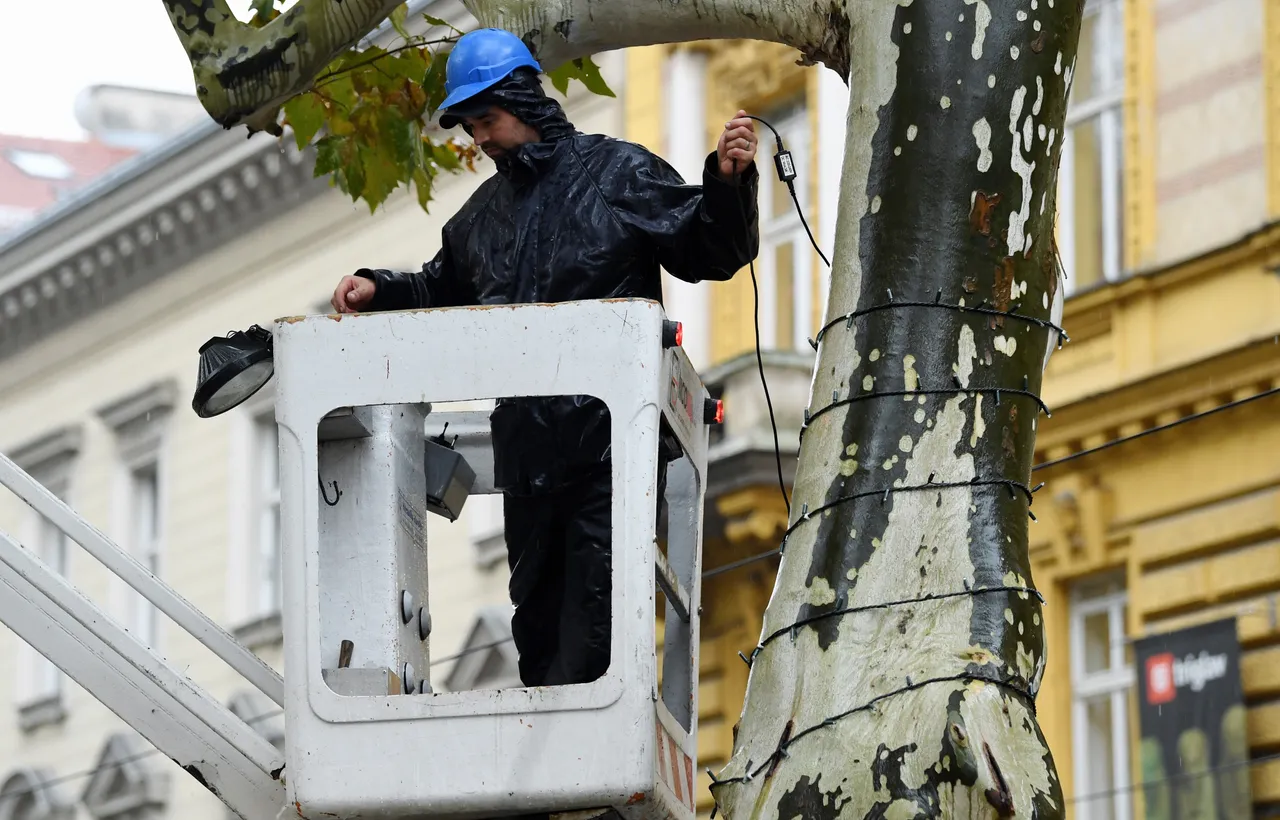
[10,427,81,730]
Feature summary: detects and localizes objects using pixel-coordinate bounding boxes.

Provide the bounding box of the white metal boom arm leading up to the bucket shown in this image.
[0,454,284,820]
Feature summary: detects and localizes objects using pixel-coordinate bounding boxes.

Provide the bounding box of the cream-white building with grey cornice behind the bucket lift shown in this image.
[0,4,623,820]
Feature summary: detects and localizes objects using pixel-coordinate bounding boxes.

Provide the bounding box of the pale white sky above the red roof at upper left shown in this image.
[0,0,259,139]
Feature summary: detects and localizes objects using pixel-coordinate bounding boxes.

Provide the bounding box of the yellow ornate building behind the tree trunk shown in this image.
[623,0,1280,820]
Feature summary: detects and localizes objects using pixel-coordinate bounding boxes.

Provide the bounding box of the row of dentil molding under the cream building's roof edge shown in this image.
[0,140,329,361]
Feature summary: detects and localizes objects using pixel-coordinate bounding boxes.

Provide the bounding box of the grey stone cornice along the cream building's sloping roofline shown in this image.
[0,0,475,365]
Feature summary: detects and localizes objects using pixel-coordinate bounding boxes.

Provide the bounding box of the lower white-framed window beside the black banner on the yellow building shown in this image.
[1070,580,1133,820]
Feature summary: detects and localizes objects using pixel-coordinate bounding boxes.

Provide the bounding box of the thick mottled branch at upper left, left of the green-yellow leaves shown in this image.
[161,0,401,134]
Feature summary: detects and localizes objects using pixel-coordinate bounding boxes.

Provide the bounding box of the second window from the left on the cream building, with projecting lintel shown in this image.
[97,381,177,647]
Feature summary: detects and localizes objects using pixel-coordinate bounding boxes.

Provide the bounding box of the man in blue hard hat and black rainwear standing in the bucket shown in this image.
[333,29,759,686]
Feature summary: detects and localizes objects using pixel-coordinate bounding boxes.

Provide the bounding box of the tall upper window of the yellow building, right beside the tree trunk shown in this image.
[1057,0,1124,294]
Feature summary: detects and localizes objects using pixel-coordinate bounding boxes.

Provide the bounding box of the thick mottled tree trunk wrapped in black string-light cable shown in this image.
[714,0,1082,820]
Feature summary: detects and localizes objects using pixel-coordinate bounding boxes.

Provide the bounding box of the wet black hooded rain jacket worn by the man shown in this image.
[356,75,759,495]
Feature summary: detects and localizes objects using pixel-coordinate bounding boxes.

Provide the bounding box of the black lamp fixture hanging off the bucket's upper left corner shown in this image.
[191,325,275,418]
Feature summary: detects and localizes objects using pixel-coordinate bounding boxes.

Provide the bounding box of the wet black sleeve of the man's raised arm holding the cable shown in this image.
[611,150,760,283]
